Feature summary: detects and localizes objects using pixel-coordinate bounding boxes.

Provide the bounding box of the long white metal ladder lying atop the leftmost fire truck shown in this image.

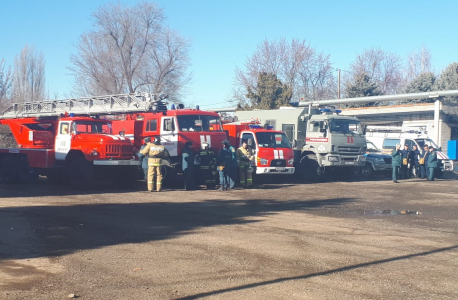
[0,93,167,119]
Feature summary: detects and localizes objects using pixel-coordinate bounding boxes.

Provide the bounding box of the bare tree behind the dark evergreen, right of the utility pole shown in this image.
[344,48,403,94]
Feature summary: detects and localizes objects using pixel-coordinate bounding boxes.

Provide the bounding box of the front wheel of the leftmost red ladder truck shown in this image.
[66,156,95,189]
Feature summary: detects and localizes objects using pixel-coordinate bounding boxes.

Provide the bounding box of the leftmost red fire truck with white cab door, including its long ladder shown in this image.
[0,94,160,188]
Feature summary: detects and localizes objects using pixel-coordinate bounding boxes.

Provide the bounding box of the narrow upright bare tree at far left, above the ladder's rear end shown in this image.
[12,45,45,102]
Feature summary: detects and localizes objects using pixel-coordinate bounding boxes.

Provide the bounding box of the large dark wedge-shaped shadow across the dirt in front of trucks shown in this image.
[0,198,352,259]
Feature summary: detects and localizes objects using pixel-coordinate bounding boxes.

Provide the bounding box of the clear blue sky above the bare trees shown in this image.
[0,0,458,108]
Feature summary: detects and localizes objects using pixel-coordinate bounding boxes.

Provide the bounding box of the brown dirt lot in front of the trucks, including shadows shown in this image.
[0,176,458,300]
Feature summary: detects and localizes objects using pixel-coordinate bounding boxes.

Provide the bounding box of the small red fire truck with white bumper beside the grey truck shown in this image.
[223,119,294,175]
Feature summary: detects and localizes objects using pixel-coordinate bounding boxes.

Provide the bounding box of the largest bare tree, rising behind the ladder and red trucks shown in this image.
[69,2,189,102]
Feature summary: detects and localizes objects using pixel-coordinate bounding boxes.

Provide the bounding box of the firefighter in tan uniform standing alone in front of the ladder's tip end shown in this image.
[141,137,170,192]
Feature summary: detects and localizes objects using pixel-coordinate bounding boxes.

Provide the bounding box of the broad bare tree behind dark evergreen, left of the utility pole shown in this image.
[233,39,336,106]
